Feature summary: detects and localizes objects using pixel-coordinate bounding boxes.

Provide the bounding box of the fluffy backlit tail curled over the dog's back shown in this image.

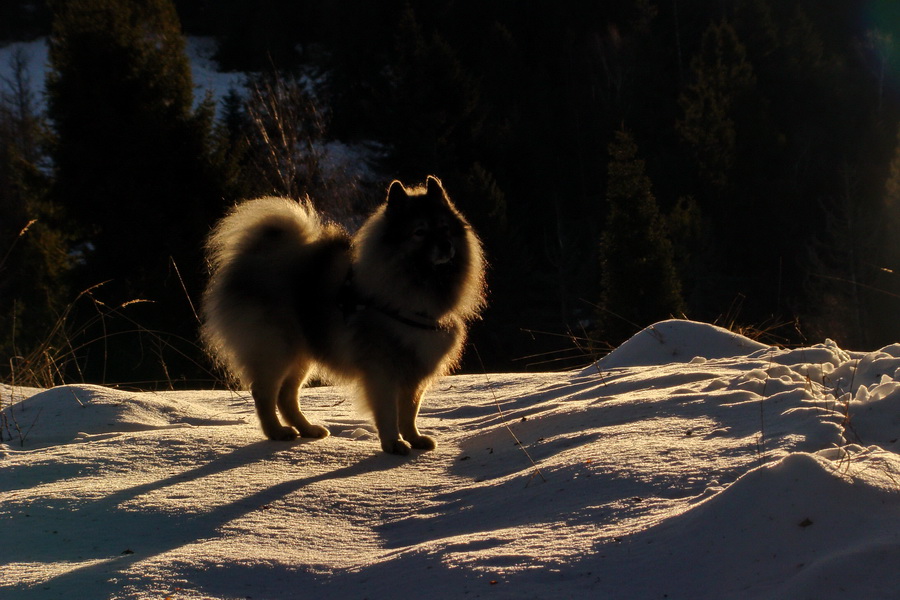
[206,197,322,278]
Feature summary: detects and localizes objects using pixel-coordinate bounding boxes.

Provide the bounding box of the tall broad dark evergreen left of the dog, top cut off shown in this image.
[47,0,230,384]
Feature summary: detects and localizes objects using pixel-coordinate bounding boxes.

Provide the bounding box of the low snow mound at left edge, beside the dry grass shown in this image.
[0,385,245,449]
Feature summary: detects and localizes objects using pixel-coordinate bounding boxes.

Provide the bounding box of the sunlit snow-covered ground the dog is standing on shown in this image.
[0,321,900,600]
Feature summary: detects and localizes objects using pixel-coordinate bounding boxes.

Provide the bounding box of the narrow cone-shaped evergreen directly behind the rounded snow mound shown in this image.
[600,128,684,343]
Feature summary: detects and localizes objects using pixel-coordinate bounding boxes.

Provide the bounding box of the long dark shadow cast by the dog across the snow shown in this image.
[16,441,400,599]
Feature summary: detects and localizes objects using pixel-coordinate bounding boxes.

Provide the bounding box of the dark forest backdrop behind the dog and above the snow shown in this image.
[0,0,900,386]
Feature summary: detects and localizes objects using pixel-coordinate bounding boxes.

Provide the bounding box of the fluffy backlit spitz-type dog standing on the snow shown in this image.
[202,177,484,454]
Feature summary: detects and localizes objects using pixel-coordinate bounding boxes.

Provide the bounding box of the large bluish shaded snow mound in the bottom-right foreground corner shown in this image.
[598,448,900,600]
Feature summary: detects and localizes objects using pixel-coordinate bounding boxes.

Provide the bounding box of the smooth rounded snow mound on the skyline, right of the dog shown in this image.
[584,319,769,374]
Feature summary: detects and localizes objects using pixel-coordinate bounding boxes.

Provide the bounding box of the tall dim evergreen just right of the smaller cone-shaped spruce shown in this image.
[676,18,797,322]
